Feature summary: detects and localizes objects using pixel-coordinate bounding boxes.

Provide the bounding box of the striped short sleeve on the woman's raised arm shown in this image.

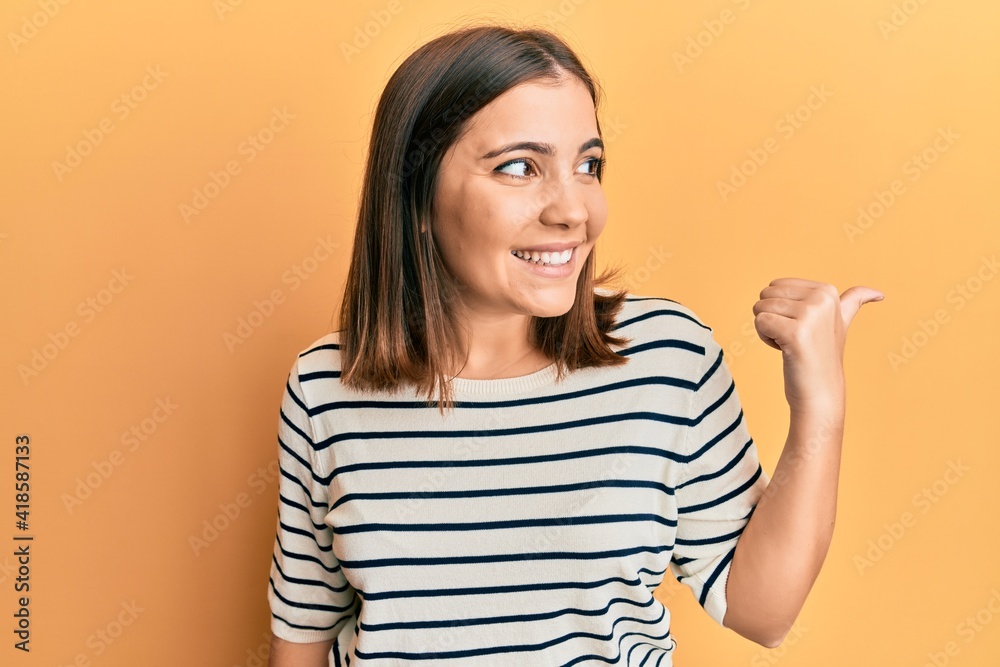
[670,329,769,625]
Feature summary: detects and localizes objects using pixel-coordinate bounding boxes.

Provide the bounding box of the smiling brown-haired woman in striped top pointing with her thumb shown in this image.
[268,26,881,667]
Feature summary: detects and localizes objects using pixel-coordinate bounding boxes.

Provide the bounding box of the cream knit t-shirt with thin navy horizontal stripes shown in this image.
[267,294,769,667]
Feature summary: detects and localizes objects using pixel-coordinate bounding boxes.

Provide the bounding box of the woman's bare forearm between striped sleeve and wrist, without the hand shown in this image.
[723,401,844,647]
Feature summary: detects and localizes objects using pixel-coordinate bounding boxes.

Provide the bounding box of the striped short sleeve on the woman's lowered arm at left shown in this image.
[267,359,358,643]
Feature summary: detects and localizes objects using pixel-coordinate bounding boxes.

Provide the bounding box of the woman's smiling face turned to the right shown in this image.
[431,76,607,317]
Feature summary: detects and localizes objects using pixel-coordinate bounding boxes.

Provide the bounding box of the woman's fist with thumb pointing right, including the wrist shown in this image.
[753,278,885,413]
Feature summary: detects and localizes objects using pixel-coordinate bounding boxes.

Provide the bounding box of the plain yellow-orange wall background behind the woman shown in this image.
[0,0,1000,667]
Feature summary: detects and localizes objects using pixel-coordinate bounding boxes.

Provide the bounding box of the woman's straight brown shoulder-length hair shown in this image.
[339,25,630,414]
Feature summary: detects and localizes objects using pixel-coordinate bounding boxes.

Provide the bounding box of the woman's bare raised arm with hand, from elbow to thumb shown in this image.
[723,278,883,648]
